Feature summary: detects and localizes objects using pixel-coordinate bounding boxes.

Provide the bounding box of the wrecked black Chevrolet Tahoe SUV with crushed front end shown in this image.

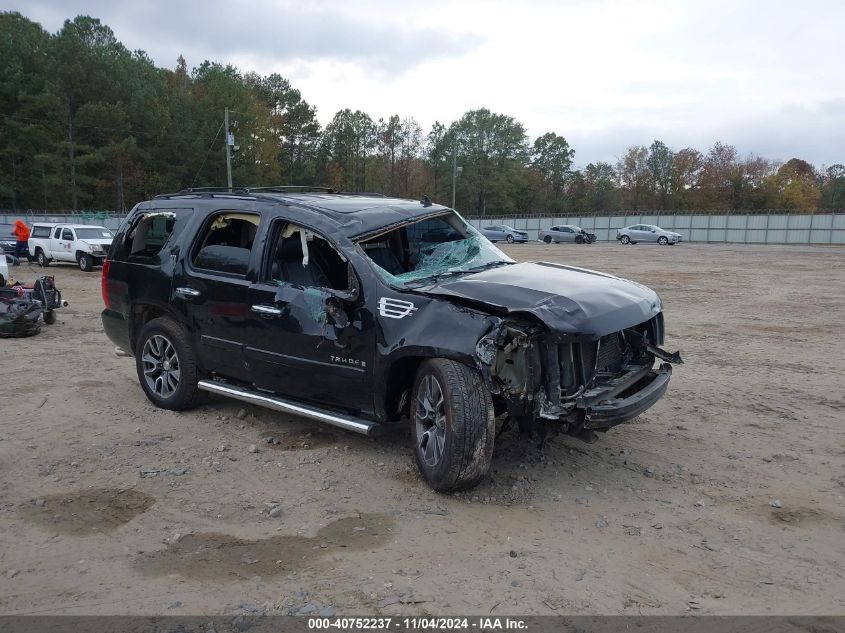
[102,187,680,490]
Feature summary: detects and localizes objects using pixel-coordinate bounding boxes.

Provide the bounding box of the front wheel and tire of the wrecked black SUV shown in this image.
[411,358,496,492]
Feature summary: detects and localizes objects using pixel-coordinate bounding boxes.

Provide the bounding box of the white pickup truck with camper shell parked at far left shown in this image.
[29,223,114,272]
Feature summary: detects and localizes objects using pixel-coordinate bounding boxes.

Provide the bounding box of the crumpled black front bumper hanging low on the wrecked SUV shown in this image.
[579,363,672,429]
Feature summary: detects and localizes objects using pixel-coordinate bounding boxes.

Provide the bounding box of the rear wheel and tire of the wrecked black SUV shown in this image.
[135,317,205,411]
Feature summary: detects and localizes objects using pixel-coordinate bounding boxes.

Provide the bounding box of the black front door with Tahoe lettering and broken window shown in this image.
[244,220,375,415]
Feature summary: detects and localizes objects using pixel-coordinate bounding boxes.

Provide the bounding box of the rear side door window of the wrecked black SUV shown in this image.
[192,211,259,275]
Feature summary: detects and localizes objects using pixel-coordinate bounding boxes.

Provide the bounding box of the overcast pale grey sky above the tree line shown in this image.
[11,0,845,166]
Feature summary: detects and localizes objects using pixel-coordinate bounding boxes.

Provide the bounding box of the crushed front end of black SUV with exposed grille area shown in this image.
[476,312,683,439]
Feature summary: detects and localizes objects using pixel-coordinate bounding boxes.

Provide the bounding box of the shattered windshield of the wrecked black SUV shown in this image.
[359,211,513,286]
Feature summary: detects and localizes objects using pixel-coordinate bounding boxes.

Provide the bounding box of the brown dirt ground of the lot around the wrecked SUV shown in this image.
[0,244,845,615]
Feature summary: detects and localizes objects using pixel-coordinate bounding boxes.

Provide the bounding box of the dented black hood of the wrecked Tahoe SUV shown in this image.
[423,262,662,338]
